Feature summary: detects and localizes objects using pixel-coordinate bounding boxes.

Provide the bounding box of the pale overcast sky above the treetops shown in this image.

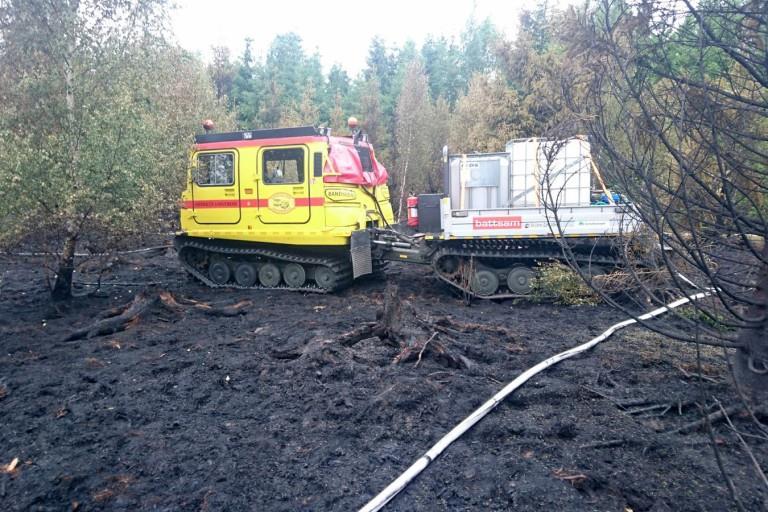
[172,0,575,76]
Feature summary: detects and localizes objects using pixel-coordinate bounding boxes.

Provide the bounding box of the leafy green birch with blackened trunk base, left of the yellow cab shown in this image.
[0,0,231,298]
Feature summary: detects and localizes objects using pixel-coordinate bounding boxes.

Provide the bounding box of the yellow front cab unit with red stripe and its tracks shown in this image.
[176,120,393,291]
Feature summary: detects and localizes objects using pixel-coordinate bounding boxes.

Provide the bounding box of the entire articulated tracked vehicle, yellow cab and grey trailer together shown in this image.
[176,123,639,299]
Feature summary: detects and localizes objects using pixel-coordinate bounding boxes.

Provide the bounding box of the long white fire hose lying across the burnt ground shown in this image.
[359,292,711,512]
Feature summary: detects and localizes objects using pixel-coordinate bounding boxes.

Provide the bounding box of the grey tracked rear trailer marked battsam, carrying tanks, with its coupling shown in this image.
[364,139,638,299]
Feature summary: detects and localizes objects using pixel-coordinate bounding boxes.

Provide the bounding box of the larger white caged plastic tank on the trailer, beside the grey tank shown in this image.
[506,137,592,208]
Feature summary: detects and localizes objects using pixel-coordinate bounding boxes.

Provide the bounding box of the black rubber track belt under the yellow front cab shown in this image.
[175,238,352,293]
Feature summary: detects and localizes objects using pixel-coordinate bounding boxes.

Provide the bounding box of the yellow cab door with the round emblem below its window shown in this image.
[258,145,312,224]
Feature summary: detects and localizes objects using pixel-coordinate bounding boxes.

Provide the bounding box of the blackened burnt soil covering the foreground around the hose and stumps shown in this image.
[0,246,768,512]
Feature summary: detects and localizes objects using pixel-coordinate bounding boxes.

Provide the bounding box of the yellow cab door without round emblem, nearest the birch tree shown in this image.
[192,150,240,224]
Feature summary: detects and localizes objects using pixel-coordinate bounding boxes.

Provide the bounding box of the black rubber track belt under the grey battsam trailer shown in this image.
[432,239,620,300]
